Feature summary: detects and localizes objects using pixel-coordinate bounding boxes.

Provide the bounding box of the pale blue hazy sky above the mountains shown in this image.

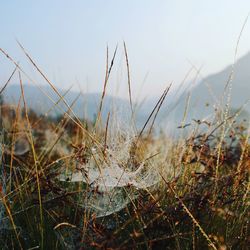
[0,0,250,97]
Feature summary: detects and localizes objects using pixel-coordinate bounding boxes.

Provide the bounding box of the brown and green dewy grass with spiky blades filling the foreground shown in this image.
[0,43,250,249]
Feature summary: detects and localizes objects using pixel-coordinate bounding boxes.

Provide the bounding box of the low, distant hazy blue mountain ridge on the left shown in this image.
[0,85,149,126]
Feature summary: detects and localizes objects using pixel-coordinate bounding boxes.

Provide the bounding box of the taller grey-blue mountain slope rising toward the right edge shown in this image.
[171,53,250,124]
